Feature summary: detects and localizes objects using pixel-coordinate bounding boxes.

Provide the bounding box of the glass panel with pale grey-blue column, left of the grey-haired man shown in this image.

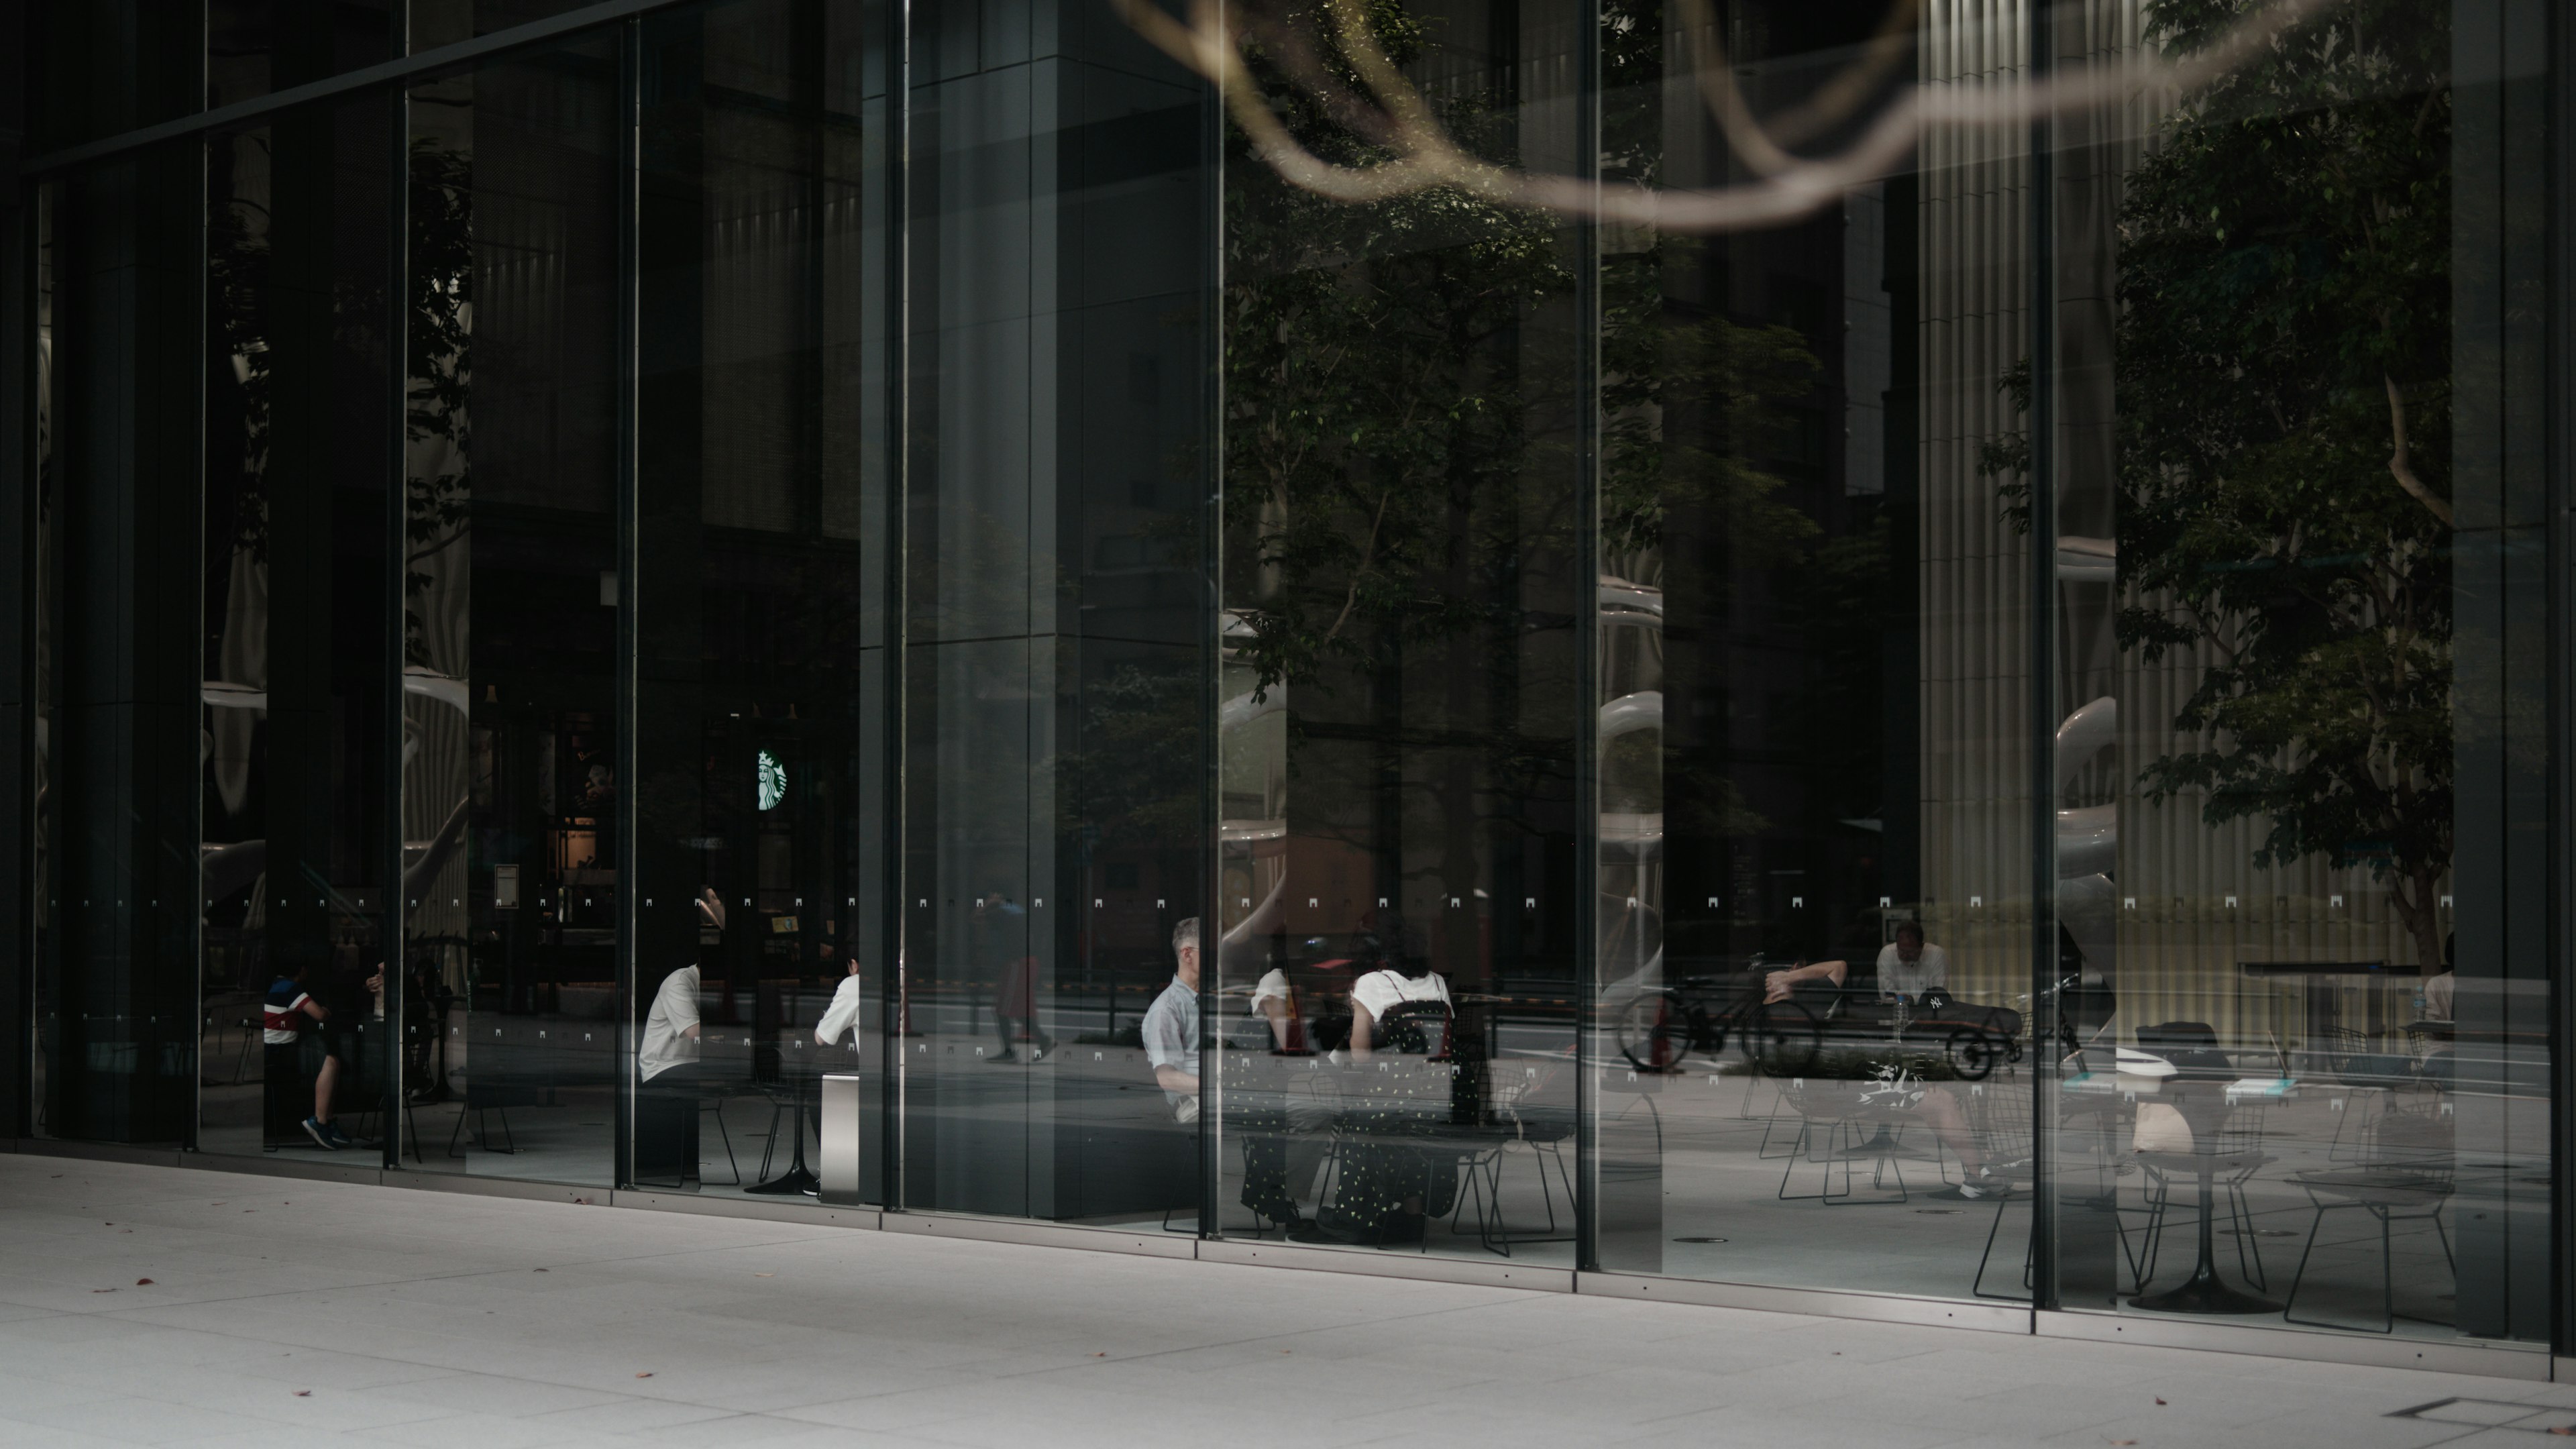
[899,0,1214,1232]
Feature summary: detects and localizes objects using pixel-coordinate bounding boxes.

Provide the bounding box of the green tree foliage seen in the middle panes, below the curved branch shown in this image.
[1224,0,1816,688]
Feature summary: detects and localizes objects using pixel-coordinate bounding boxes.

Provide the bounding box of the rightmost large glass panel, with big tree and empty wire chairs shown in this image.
[2040,0,2563,1338]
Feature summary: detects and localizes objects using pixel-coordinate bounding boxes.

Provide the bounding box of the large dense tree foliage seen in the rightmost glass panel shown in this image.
[1986,0,2453,972]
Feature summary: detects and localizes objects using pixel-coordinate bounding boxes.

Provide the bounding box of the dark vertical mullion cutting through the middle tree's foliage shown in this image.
[1571,0,1610,1271]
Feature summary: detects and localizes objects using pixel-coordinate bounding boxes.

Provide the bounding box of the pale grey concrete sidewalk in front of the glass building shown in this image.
[0,1155,2576,1449]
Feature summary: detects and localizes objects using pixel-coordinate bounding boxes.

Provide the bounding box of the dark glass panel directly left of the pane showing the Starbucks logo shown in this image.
[386,41,626,1183]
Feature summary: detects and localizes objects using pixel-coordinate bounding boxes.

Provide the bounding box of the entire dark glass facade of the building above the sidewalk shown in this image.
[0,0,2576,1361]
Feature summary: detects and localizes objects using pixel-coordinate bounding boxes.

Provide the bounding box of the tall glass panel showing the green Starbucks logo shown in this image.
[631,0,886,1199]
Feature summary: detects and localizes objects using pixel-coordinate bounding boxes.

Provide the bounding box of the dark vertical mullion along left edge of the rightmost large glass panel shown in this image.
[2025,0,2066,1312]
